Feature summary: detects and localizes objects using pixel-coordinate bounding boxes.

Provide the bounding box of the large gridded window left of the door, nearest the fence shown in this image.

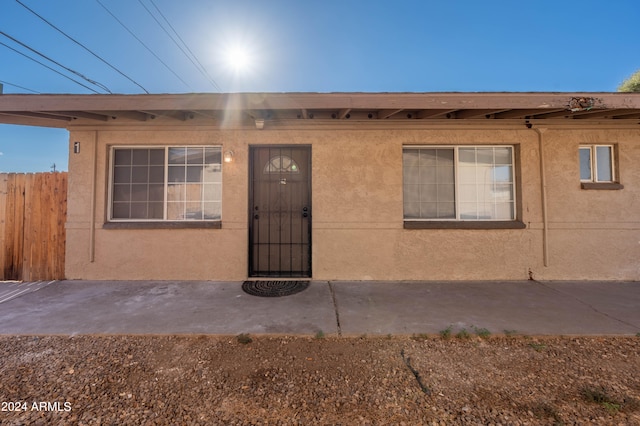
[109,146,222,221]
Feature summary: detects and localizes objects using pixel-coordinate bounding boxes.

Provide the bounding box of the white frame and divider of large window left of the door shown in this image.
[107,145,224,223]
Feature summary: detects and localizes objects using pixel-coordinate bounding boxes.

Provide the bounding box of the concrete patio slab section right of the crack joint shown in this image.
[332,281,640,335]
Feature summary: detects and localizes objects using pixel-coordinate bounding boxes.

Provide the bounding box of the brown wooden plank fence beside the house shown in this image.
[0,173,67,281]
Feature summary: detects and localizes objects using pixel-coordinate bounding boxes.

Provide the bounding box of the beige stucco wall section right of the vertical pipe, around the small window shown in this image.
[540,130,640,280]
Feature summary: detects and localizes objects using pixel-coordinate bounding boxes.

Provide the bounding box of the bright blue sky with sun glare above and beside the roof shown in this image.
[0,0,640,172]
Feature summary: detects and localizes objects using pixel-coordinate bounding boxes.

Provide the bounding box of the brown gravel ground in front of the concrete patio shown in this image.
[0,335,640,425]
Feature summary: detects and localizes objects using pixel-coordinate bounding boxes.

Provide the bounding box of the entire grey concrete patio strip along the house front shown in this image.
[0,281,640,336]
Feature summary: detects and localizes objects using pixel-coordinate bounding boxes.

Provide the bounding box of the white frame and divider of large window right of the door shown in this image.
[402,144,519,223]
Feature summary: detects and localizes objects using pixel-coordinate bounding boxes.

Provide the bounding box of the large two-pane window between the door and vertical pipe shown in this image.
[403,146,516,221]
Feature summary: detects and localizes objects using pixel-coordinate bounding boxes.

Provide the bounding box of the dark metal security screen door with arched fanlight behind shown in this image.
[249,146,311,277]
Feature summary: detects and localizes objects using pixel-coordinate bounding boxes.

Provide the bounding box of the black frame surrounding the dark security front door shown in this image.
[247,144,313,279]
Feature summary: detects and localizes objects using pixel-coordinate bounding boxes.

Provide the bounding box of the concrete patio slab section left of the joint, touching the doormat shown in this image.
[0,281,337,334]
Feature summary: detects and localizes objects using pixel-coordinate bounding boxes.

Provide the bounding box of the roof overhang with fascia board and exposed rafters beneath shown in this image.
[0,93,640,128]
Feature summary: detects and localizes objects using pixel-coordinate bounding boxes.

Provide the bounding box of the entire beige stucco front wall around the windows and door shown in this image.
[66,120,640,280]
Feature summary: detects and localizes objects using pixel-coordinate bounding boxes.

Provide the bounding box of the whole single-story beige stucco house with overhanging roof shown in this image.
[0,93,640,280]
